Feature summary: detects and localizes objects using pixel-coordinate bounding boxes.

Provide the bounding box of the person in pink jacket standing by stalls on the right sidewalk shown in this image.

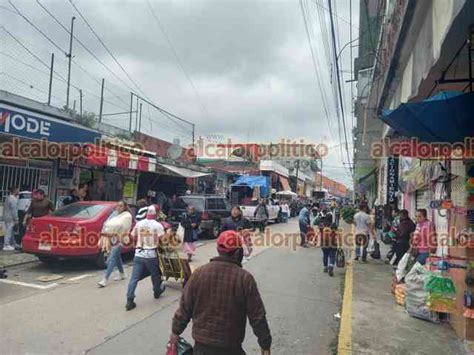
[412,208,437,265]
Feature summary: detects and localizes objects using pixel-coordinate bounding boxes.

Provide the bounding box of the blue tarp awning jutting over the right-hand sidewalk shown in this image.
[381,91,474,143]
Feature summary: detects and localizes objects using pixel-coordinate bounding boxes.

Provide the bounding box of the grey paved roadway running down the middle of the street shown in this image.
[0,221,343,354]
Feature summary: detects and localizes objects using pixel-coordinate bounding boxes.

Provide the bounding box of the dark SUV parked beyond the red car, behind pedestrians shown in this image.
[168,195,230,238]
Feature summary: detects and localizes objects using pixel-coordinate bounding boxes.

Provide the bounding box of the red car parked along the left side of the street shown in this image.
[22,201,136,268]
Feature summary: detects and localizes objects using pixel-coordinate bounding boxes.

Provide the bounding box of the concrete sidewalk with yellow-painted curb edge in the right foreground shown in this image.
[339,238,467,354]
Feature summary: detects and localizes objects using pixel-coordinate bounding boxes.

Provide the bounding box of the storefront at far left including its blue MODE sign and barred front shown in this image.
[0,97,101,206]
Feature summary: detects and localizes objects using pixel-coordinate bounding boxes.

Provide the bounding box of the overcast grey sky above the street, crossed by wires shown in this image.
[0,0,359,185]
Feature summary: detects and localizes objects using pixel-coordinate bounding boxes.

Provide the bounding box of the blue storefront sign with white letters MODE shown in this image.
[0,104,101,143]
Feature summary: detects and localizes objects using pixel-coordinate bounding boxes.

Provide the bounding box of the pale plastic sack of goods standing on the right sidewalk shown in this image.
[405,263,439,322]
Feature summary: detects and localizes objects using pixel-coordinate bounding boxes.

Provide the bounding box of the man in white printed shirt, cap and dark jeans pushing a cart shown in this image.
[125,206,165,311]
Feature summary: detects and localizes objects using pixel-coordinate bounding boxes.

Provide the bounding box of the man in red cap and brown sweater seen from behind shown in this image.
[170,230,272,355]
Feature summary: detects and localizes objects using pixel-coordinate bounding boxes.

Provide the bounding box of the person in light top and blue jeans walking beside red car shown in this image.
[99,200,133,287]
